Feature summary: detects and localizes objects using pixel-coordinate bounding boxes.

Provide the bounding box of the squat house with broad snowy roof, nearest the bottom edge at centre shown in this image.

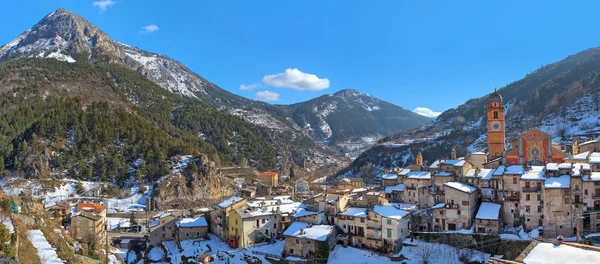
[283,222,335,261]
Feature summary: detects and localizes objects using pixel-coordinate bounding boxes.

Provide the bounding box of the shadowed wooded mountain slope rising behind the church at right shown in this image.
[340,47,600,179]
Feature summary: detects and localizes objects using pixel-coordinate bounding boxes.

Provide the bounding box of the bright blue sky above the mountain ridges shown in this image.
[0,0,600,111]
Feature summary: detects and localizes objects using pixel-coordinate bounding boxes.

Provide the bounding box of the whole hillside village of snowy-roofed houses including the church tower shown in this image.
[0,91,600,263]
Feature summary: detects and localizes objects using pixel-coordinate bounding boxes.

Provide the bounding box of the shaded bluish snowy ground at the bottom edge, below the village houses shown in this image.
[327,239,490,264]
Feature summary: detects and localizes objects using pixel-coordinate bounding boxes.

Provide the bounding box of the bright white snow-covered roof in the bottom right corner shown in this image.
[523,243,600,264]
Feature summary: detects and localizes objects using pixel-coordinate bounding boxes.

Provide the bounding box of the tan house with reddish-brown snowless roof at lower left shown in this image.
[70,203,107,243]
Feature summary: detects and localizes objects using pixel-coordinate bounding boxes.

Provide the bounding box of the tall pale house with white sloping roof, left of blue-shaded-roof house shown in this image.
[444,182,478,230]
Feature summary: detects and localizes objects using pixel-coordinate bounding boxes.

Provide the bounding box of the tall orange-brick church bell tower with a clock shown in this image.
[487,88,506,160]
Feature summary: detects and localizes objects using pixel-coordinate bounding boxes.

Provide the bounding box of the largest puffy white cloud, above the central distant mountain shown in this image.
[263,68,329,91]
